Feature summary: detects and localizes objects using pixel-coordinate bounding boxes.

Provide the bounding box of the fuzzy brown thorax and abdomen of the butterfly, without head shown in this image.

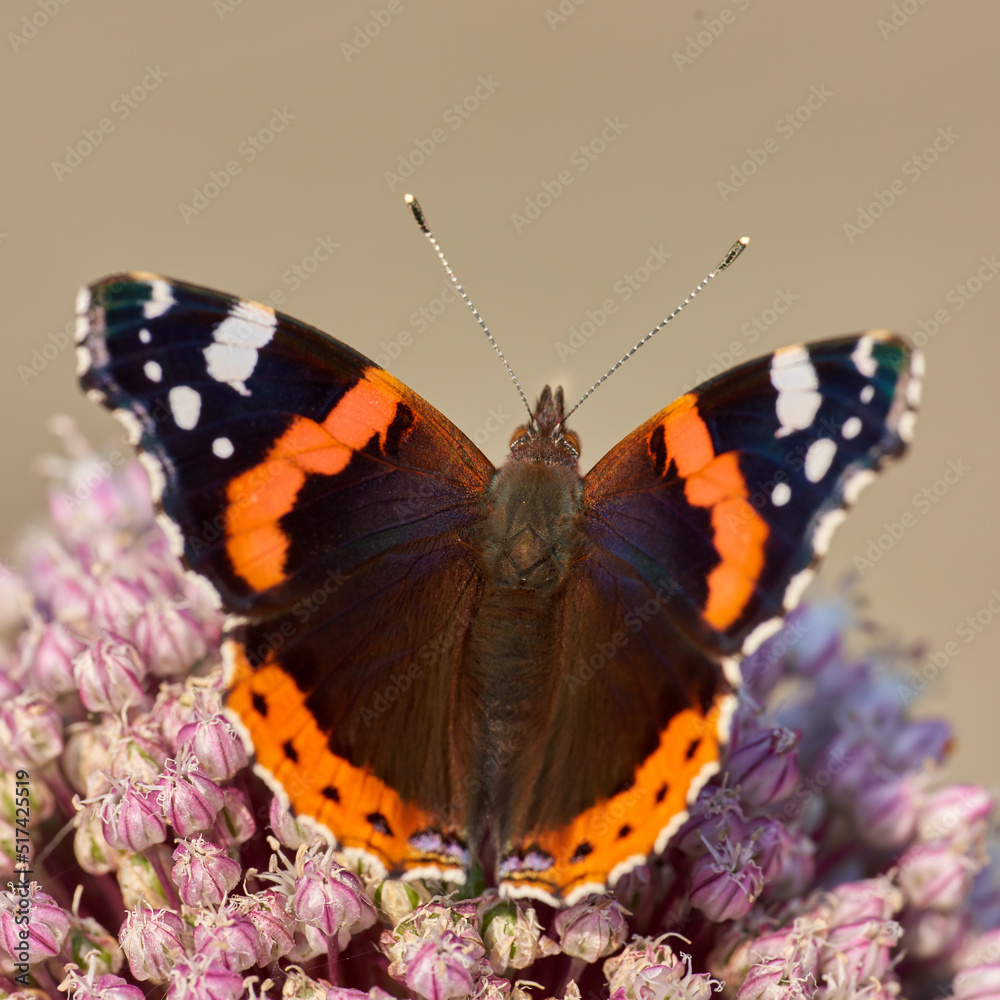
[458,459,583,856]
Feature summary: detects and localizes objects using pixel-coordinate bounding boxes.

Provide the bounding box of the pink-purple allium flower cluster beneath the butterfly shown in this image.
[0,423,1000,1000]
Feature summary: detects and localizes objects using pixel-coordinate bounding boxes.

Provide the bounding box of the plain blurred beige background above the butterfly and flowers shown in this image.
[0,0,1000,784]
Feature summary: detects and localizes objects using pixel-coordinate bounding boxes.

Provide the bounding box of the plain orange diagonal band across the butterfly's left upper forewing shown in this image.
[226,369,401,591]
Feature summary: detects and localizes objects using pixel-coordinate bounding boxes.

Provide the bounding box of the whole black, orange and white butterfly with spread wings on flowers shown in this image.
[77,250,922,905]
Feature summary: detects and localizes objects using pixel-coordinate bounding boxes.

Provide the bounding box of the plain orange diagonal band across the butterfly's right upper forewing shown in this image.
[663,393,770,630]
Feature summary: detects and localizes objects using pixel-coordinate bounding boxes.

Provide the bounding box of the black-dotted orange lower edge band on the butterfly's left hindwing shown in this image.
[226,643,454,872]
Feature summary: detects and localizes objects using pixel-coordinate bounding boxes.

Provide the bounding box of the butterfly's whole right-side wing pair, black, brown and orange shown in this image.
[502,331,922,901]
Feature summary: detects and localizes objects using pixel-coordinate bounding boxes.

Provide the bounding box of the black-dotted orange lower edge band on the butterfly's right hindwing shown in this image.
[508,695,732,899]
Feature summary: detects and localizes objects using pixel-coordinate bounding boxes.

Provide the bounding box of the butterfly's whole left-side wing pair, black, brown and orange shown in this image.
[78,274,493,872]
